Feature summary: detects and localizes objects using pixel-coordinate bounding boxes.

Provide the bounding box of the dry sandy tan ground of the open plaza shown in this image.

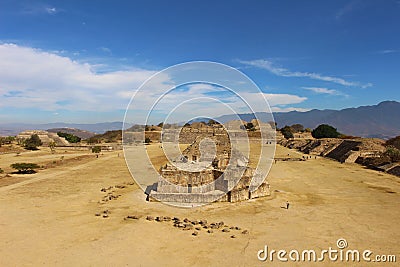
[0,147,400,266]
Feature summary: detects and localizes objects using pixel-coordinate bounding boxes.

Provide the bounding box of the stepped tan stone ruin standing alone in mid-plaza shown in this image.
[146,131,270,204]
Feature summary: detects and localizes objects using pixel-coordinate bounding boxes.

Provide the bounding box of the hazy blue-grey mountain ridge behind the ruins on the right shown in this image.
[216,101,400,139]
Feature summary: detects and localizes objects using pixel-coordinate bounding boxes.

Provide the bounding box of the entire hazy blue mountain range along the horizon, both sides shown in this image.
[0,101,400,139]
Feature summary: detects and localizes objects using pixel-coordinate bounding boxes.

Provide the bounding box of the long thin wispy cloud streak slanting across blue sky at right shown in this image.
[239,59,372,88]
